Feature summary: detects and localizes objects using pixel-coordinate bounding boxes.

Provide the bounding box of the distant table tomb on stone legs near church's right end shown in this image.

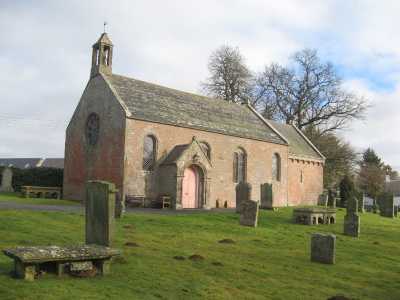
[293,207,336,225]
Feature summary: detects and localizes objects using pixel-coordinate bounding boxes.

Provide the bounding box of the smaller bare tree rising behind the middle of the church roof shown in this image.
[201,45,253,103]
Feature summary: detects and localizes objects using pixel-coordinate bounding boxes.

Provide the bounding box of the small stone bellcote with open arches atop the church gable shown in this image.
[90,32,113,78]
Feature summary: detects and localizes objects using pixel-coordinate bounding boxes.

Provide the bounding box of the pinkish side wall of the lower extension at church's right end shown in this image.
[288,158,323,206]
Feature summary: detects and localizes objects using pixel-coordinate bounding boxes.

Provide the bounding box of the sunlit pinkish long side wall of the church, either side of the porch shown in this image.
[124,119,288,207]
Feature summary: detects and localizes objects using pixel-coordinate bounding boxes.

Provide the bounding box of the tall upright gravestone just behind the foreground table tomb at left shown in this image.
[85,181,116,247]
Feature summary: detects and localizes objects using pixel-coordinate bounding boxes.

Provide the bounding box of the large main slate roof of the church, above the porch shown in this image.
[102,74,287,145]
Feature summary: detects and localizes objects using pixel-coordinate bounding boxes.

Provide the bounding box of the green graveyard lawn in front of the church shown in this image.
[0,208,400,300]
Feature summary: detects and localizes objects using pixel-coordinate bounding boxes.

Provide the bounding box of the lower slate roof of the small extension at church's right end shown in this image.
[268,120,323,160]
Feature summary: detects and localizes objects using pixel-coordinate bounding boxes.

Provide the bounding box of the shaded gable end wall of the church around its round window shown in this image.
[63,76,125,200]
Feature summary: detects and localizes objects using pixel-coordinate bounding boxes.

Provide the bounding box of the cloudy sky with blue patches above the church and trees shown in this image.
[0,0,400,169]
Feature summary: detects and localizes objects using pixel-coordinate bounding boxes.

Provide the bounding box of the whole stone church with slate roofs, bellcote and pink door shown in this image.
[64,33,324,209]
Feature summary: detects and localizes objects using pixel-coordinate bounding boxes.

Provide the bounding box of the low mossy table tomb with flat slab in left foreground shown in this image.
[3,245,120,281]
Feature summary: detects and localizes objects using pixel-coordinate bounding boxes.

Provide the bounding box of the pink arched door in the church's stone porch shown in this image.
[182,165,204,208]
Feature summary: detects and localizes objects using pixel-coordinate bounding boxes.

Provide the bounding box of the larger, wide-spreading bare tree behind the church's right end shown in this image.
[253,49,367,134]
